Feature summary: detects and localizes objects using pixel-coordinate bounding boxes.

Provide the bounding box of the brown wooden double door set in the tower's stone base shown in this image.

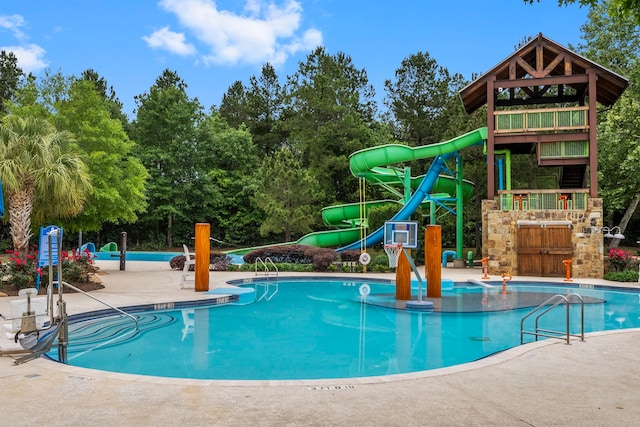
[518,223,573,277]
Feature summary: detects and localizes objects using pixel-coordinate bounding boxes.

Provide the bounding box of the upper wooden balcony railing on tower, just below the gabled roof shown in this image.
[493,107,589,133]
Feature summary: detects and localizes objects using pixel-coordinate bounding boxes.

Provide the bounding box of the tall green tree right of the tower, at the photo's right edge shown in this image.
[577,1,640,247]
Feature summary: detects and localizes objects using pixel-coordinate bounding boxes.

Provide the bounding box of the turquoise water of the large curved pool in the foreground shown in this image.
[49,278,640,380]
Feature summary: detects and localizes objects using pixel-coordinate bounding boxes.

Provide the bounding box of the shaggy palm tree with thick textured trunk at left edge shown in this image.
[0,114,92,256]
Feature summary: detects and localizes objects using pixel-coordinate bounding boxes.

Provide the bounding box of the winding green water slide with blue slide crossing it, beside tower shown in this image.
[227,128,487,255]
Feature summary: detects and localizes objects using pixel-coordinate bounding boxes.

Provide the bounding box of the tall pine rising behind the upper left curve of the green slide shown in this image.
[281,47,376,204]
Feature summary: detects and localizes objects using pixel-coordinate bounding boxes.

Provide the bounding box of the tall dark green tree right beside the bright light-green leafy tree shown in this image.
[132,70,202,247]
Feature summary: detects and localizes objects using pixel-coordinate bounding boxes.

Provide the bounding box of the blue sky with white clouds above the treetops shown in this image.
[0,0,592,116]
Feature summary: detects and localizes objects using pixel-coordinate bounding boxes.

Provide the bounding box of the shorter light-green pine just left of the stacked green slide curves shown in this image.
[254,147,321,242]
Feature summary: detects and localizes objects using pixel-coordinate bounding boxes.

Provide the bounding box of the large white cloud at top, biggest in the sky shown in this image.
[149,0,322,65]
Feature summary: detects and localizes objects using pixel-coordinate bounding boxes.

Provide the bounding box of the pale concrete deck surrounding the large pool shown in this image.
[0,261,640,427]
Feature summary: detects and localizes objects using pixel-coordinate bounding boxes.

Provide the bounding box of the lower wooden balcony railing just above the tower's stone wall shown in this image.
[498,188,589,211]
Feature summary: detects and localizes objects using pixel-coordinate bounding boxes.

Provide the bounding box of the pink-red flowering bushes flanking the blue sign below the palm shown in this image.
[0,249,97,289]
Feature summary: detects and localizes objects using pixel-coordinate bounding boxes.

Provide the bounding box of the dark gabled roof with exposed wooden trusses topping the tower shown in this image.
[460,33,629,114]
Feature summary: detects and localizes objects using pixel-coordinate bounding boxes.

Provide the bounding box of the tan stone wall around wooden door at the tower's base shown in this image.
[482,198,604,278]
